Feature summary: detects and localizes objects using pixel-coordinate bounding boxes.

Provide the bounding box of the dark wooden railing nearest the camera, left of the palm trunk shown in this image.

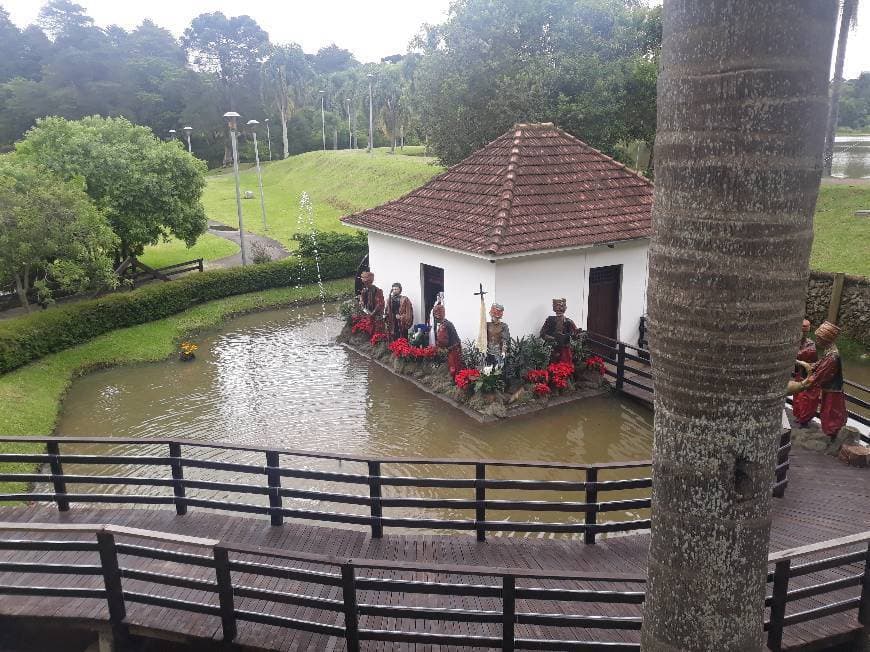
[0,523,646,652]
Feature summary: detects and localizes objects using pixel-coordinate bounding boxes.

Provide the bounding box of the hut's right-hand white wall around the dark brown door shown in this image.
[487,240,649,344]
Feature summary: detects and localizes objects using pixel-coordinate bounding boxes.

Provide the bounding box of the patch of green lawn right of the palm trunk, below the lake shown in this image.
[810,181,870,276]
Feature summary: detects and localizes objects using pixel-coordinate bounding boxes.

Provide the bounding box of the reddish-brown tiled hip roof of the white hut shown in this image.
[342,123,653,256]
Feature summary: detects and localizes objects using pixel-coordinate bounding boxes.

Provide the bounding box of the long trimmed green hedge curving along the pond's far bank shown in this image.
[0,254,359,373]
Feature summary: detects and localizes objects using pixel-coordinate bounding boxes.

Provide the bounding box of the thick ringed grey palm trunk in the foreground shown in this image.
[642,0,837,651]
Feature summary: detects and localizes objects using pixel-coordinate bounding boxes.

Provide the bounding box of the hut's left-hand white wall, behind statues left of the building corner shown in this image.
[369,232,496,340]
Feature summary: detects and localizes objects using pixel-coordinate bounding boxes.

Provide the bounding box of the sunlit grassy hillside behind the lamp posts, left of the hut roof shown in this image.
[203,147,443,248]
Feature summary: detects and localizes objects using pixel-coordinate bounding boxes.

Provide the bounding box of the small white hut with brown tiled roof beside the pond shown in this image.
[342,123,652,344]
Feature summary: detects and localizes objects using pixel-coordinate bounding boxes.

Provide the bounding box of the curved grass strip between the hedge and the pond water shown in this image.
[0,279,353,492]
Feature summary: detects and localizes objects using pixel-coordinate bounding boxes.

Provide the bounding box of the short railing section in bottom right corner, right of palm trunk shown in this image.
[764,532,870,650]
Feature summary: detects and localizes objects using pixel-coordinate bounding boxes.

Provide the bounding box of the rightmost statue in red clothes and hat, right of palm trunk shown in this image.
[790,321,848,439]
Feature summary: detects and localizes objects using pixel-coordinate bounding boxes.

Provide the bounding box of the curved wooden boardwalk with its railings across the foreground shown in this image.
[0,433,870,650]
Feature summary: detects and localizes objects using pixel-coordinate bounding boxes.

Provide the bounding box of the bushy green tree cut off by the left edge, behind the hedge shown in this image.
[0,156,115,312]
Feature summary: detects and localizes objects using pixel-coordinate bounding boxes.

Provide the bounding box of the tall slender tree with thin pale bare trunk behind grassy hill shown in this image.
[263,43,312,158]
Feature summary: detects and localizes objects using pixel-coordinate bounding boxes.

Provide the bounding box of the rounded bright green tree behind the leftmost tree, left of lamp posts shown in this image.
[16,116,207,260]
